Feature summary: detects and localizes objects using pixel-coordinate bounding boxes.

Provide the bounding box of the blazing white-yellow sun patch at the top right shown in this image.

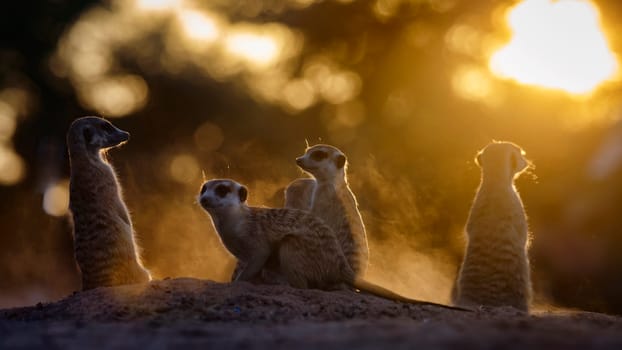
[489,0,617,94]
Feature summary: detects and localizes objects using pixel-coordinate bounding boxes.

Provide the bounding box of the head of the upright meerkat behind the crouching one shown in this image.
[296,145,347,180]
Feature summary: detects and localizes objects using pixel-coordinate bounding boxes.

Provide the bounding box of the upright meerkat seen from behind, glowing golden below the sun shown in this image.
[454,141,531,311]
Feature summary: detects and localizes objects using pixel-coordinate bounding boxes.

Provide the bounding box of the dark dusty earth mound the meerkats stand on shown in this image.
[0,279,622,350]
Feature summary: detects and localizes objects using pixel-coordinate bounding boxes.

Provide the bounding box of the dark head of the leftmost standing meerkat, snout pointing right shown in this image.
[67,117,130,153]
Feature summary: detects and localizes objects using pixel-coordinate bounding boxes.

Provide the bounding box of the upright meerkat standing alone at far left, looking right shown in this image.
[67,117,151,290]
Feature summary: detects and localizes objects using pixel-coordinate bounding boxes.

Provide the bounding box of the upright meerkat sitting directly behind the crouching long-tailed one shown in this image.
[285,144,369,276]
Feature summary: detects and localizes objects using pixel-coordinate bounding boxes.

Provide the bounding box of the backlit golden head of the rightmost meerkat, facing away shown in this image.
[475,141,532,181]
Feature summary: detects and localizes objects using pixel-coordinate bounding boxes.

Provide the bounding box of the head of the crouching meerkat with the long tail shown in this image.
[199,179,248,212]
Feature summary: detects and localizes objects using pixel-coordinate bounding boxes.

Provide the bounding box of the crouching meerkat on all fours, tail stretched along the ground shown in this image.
[198,179,464,310]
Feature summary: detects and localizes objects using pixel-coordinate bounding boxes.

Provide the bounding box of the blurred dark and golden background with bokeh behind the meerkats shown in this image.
[0,0,622,313]
